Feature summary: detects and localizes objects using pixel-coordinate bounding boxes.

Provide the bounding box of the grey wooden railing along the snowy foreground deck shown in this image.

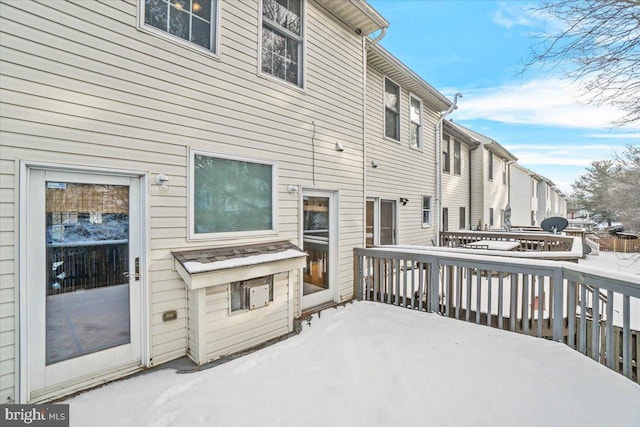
[354,247,640,383]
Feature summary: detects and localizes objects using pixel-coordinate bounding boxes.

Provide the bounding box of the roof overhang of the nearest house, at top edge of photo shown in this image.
[316,0,389,36]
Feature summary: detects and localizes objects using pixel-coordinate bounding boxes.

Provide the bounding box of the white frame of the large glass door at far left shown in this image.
[16,161,151,403]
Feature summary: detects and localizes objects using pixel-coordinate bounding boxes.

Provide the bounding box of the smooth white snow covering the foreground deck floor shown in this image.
[66,302,640,427]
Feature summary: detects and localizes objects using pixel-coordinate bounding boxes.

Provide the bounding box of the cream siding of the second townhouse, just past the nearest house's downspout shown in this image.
[365,66,439,245]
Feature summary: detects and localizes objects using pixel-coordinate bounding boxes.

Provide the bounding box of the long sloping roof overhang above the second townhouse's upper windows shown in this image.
[367,44,453,111]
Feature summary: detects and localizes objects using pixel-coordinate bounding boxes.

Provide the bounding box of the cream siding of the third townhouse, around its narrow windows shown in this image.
[442,136,475,231]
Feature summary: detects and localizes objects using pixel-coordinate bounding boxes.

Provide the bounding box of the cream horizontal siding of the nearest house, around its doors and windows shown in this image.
[0,0,364,402]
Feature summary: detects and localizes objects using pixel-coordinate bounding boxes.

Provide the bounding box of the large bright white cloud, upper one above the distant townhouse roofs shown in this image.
[448,78,640,129]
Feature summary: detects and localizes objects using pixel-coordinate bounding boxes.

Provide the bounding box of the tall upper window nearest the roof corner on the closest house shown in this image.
[261,0,303,87]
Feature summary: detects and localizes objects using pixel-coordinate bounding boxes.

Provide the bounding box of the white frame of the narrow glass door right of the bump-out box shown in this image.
[299,188,340,311]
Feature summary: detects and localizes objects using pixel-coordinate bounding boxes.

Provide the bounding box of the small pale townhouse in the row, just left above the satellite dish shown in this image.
[509,163,542,227]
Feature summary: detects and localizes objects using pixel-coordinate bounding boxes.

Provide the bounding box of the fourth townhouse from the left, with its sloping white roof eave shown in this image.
[456,124,518,230]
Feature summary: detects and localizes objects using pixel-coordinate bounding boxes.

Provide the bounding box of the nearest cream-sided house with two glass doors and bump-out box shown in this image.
[0,0,390,403]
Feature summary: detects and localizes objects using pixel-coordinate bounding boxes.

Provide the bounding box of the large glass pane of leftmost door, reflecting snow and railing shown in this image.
[43,181,131,365]
